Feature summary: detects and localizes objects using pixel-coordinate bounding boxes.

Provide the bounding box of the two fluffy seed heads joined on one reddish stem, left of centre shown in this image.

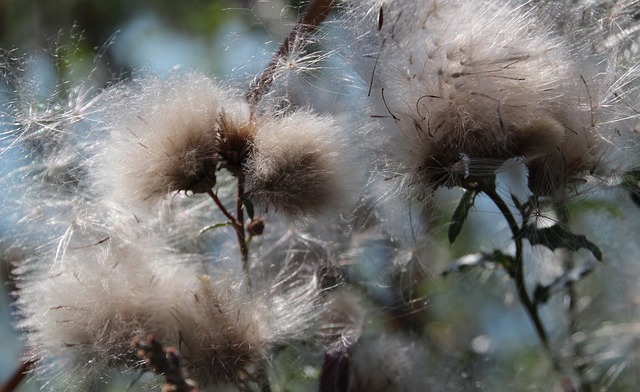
[94,73,348,216]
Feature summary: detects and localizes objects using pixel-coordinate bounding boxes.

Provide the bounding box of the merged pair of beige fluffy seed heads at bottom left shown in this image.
[19,217,319,385]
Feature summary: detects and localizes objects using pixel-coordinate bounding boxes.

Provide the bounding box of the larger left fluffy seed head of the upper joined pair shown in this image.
[95,73,254,202]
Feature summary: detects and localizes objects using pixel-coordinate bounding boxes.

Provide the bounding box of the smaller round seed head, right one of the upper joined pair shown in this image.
[247,110,356,217]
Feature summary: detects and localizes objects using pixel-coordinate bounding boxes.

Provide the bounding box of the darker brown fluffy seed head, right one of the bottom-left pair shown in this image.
[174,276,319,385]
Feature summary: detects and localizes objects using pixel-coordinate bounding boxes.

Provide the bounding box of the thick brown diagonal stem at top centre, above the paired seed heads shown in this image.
[246,0,334,106]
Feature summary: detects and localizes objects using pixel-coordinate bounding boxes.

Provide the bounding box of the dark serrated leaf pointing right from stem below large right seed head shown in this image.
[523,225,602,261]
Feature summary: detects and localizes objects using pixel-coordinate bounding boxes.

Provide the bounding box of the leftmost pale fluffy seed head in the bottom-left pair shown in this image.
[18,225,195,387]
